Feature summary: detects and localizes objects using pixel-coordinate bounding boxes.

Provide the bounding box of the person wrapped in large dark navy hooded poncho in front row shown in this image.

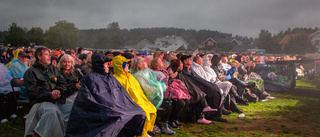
[66,54,146,137]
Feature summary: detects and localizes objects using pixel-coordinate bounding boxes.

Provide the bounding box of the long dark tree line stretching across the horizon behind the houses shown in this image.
[0,20,319,54]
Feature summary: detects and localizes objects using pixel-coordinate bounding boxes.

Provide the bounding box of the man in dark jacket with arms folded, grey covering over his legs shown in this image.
[23,47,66,136]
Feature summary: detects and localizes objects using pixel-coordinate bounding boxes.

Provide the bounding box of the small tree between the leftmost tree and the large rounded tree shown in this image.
[27,27,44,45]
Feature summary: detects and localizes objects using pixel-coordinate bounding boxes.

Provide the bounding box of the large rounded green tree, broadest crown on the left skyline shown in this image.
[44,20,78,48]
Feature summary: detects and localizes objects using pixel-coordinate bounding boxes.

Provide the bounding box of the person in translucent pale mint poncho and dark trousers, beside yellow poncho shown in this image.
[131,57,175,135]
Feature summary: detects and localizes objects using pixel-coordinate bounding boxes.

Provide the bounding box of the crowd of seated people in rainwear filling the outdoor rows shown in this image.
[0,47,282,137]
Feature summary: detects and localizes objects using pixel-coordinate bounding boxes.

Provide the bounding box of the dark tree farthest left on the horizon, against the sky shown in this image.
[4,22,30,47]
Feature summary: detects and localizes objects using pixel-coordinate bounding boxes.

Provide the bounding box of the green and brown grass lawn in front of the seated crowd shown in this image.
[0,76,320,137]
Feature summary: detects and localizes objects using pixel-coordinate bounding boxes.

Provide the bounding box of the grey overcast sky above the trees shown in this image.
[0,0,320,37]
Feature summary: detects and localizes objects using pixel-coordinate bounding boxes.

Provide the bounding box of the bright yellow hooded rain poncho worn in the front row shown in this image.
[113,56,157,137]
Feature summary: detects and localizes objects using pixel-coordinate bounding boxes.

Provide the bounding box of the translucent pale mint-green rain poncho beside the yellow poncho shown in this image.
[132,68,167,109]
